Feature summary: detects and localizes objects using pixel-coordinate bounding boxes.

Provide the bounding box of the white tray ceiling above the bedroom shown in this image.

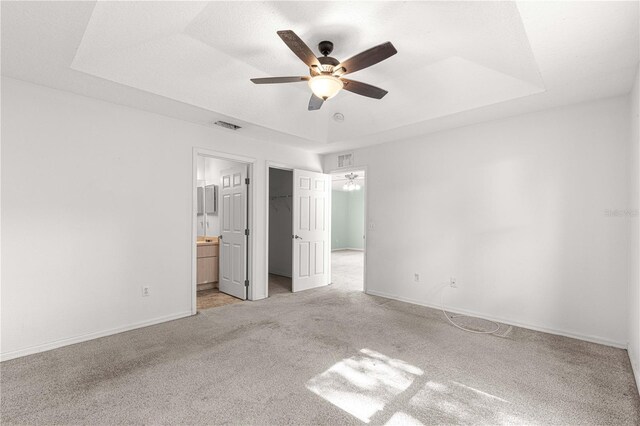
[2,1,639,152]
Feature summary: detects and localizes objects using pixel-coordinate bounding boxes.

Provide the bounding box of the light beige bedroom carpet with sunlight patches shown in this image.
[0,254,640,425]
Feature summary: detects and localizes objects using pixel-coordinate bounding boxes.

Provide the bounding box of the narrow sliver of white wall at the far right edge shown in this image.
[627,68,640,388]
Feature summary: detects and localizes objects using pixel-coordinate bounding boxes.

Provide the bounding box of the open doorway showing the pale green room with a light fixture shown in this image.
[331,170,366,291]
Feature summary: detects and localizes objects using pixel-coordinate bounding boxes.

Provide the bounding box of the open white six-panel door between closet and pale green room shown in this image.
[292,170,331,291]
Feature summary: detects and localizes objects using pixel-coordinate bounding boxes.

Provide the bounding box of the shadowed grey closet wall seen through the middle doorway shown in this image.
[269,169,293,277]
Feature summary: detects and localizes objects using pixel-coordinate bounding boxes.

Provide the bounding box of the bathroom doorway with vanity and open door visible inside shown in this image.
[192,152,251,313]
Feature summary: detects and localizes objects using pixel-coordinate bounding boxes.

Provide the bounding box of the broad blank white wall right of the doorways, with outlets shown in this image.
[324,97,629,346]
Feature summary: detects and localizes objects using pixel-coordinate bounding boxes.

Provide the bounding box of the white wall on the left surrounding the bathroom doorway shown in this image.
[1,78,321,359]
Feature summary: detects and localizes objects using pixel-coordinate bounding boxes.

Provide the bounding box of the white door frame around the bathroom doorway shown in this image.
[189,147,258,315]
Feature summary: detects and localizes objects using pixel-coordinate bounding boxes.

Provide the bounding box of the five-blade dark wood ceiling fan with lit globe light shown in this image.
[251,30,398,111]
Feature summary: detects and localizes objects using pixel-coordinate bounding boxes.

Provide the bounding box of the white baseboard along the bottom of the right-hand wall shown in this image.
[366,290,624,350]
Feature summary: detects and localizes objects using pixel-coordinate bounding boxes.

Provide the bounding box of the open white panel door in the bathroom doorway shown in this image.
[219,165,247,299]
